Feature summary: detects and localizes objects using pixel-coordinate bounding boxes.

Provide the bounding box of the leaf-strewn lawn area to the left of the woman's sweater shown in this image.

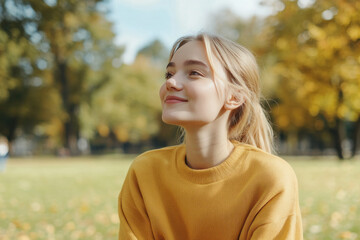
[0,156,133,240]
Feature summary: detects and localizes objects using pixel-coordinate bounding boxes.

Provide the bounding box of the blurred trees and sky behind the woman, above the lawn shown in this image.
[0,0,360,159]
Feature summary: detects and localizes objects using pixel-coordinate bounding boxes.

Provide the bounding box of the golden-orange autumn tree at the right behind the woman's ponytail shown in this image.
[263,0,360,159]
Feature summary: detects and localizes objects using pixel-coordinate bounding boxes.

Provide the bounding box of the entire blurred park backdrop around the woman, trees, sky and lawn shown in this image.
[0,0,360,240]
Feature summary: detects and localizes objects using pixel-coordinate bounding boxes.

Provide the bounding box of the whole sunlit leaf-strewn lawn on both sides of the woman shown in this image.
[0,155,360,240]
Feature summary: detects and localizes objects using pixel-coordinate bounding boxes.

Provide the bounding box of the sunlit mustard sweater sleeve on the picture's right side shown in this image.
[249,162,303,240]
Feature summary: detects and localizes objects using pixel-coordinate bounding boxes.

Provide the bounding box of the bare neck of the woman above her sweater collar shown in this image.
[185,126,234,169]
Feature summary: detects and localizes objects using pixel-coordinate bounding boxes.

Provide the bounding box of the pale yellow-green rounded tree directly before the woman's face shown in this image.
[80,55,162,150]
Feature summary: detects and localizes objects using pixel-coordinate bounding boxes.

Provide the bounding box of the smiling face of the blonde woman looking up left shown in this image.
[160,41,226,127]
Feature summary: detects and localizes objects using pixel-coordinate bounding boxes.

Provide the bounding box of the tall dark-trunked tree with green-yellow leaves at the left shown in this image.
[32,0,121,153]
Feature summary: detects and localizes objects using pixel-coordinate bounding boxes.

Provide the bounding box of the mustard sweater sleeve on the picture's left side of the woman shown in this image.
[118,168,154,240]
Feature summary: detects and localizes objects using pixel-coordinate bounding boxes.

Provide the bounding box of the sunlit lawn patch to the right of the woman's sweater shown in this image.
[285,157,360,240]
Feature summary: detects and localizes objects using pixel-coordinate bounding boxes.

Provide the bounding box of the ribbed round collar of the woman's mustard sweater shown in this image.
[175,141,247,184]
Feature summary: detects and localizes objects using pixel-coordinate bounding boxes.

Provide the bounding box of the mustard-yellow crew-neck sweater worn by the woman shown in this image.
[118,142,303,240]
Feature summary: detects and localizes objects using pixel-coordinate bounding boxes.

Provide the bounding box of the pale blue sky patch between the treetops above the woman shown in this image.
[108,0,270,63]
